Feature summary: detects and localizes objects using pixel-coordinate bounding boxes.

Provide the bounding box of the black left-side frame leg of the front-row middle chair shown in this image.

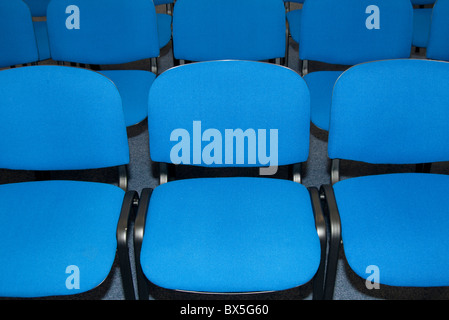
[133,188,153,300]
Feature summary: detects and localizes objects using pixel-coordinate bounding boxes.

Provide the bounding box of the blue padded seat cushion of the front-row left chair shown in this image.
[0,181,124,297]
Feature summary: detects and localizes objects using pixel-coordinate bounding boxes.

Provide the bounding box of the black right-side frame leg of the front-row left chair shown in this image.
[117,191,139,300]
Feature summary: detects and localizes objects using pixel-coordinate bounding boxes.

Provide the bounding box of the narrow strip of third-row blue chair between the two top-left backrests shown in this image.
[23,0,51,61]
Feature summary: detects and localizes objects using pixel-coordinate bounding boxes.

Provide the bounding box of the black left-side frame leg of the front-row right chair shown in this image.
[320,184,342,300]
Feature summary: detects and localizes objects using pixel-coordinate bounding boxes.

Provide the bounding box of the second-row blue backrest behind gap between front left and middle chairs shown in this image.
[47,0,159,64]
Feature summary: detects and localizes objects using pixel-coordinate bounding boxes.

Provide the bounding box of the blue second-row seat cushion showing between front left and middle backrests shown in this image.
[100,70,156,126]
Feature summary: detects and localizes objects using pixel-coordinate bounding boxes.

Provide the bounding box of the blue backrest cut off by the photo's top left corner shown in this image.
[0,0,39,68]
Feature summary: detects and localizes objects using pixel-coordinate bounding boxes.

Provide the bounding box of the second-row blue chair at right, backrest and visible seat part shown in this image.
[299,0,413,131]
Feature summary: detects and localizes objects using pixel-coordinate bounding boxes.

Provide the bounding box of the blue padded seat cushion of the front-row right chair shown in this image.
[334,173,449,287]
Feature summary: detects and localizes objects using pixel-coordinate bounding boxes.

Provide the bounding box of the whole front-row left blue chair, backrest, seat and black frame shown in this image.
[0,66,138,299]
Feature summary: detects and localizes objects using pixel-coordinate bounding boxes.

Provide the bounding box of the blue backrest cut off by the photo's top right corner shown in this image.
[426,0,449,60]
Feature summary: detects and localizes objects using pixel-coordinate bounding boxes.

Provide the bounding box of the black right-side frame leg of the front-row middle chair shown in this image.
[308,187,327,300]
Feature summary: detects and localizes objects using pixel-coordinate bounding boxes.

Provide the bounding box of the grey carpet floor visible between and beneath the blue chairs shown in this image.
[0,3,449,300]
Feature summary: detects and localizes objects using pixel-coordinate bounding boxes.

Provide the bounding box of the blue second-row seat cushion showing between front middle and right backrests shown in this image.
[304,71,342,130]
